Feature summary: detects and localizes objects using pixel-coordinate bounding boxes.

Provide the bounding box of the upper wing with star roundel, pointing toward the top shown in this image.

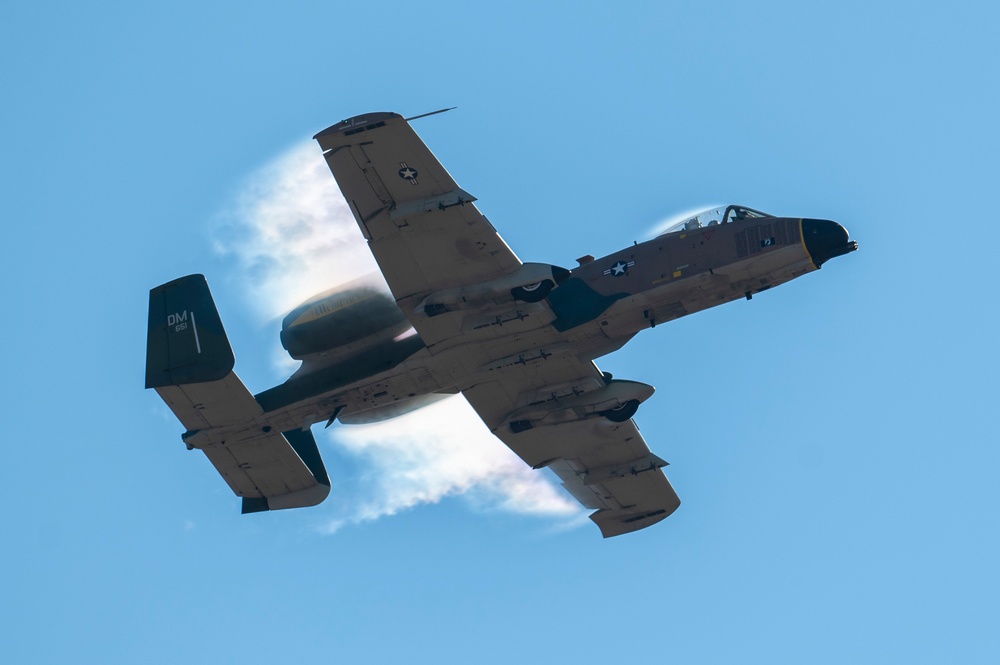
[314,113,521,316]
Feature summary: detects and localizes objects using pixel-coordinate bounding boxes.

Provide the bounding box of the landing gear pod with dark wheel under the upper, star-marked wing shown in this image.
[416,263,570,316]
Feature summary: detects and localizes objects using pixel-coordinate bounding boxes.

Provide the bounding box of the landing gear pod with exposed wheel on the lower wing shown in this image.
[507,379,656,432]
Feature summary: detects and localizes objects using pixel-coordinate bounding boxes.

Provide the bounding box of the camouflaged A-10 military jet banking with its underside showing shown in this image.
[146,113,858,537]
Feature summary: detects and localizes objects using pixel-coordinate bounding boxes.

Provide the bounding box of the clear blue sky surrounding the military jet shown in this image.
[0,2,1000,663]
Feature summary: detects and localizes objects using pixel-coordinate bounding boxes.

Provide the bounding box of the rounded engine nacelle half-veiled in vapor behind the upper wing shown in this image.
[281,278,410,360]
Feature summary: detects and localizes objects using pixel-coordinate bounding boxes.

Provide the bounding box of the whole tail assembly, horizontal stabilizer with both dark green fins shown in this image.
[146,275,330,513]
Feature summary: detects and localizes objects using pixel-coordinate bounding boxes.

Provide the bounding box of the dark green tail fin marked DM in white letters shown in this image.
[146,275,236,388]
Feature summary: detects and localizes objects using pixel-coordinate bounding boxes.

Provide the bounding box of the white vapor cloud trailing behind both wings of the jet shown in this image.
[216,143,583,532]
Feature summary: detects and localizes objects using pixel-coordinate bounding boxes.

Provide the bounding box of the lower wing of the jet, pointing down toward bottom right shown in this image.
[463,357,680,538]
